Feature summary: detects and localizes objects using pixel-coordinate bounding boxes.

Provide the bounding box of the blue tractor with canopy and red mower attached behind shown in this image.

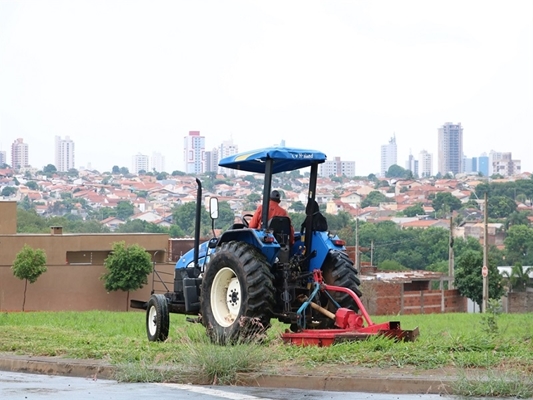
[130,147,418,346]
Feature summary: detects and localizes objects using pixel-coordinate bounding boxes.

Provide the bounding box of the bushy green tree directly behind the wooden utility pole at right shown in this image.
[454,250,503,309]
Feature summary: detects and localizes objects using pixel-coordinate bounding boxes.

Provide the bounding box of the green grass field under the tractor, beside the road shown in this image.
[0,311,533,397]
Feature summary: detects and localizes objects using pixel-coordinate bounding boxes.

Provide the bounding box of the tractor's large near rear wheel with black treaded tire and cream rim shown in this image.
[201,241,275,344]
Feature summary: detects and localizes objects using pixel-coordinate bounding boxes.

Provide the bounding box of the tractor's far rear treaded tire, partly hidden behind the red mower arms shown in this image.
[322,251,362,312]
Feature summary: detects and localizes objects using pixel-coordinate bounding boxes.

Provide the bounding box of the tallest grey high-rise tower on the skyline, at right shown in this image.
[437,122,463,175]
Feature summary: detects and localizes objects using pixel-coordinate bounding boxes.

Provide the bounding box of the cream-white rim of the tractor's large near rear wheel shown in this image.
[211,268,242,327]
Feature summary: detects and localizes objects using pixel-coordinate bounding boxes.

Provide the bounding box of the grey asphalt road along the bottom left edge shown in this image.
[0,371,453,400]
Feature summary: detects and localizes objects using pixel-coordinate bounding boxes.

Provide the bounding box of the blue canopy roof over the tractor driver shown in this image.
[218,147,326,174]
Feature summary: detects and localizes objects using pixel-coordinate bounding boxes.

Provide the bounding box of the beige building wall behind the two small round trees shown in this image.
[0,227,174,311]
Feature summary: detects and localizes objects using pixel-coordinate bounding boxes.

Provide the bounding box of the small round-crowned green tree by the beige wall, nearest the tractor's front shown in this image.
[102,242,153,310]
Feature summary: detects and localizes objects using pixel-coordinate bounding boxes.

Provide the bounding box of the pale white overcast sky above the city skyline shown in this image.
[0,0,533,175]
